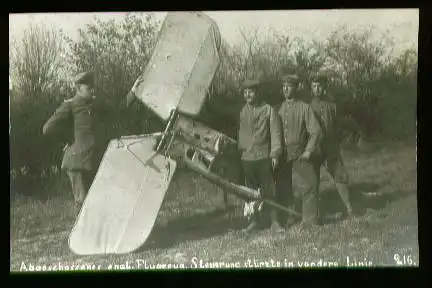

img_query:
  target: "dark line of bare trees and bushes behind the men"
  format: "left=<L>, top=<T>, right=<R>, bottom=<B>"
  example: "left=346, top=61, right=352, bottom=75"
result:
left=9, top=13, right=417, bottom=196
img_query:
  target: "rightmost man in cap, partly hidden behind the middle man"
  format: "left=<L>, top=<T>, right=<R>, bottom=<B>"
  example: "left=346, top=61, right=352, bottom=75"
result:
left=311, top=74, right=353, bottom=216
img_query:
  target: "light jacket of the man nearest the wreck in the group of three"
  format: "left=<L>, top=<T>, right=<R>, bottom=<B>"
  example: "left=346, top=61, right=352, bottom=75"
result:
left=238, top=104, right=282, bottom=161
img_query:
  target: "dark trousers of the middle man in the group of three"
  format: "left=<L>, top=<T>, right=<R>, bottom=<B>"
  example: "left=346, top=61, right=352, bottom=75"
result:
left=276, top=158, right=321, bottom=225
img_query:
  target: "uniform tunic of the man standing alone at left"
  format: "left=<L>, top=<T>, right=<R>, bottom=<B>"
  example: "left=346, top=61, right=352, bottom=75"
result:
left=43, top=96, right=95, bottom=171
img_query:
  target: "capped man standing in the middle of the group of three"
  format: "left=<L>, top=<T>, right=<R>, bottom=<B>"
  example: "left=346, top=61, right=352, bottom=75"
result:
left=276, top=75, right=322, bottom=226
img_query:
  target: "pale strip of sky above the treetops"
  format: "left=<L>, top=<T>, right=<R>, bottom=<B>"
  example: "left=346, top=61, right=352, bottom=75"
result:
left=9, top=9, right=419, bottom=54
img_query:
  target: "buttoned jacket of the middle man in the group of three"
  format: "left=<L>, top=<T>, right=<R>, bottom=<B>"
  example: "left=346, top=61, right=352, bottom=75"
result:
left=279, top=99, right=322, bottom=161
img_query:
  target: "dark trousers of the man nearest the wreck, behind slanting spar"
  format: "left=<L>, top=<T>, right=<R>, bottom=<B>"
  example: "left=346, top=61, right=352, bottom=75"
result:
left=242, top=158, right=275, bottom=222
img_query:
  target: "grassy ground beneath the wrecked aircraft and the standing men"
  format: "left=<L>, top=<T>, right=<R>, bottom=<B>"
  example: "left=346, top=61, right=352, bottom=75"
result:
left=10, top=144, right=419, bottom=271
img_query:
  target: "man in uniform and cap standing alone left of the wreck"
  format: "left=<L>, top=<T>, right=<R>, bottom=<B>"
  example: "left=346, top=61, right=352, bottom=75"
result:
left=43, top=72, right=95, bottom=209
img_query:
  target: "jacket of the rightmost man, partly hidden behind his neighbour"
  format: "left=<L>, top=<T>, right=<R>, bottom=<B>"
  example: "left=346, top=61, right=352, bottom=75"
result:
left=310, top=98, right=339, bottom=155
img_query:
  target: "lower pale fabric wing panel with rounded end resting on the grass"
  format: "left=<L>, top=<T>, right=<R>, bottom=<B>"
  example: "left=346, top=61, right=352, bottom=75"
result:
left=69, top=137, right=176, bottom=255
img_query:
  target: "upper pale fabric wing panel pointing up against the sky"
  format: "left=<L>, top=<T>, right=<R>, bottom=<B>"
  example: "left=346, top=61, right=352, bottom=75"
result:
left=135, top=12, right=221, bottom=120
